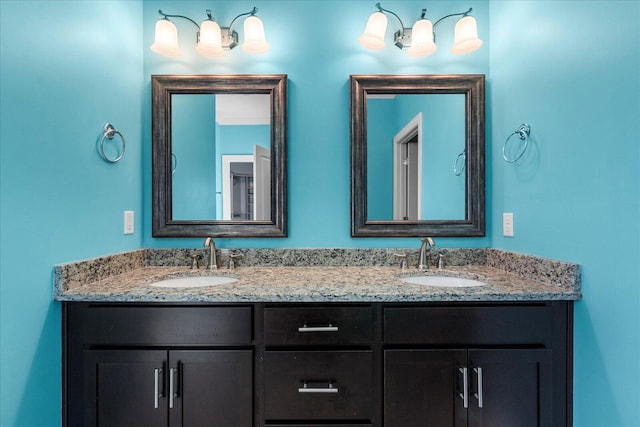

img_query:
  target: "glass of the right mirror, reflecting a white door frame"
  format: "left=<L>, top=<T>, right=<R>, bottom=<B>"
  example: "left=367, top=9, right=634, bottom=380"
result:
left=367, top=94, right=465, bottom=220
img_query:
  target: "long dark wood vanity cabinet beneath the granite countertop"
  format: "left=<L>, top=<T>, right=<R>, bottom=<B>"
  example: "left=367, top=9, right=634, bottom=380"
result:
left=63, top=301, right=573, bottom=427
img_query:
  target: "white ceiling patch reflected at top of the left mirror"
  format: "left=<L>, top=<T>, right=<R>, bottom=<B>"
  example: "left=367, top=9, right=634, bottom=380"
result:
left=216, top=94, right=271, bottom=125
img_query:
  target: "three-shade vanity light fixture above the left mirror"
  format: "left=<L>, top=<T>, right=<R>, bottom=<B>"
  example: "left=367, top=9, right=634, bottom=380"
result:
left=151, top=7, right=269, bottom=58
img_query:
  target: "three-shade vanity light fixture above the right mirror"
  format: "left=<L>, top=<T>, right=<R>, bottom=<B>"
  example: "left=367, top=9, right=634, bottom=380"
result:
left=358, top=3, right=482, bottom=57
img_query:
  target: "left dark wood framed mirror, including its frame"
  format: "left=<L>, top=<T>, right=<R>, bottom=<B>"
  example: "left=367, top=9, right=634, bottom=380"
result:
left=151, top=74, right=287, bottom=237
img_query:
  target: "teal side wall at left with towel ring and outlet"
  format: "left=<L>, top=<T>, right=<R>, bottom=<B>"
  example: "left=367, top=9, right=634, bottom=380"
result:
left=0, top=0, right=143, bottom=427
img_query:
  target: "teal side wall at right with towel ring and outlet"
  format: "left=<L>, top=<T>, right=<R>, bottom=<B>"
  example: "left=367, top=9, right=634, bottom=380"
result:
left=487, top=1, right=640, bottom=427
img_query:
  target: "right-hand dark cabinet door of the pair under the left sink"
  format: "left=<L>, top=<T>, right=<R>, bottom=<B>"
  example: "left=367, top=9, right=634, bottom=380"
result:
left=168, top=350, right=253, bottom=427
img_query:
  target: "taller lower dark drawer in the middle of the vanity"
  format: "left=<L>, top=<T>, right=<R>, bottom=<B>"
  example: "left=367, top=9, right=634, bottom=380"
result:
left=264, top=351, right=373, bottom=421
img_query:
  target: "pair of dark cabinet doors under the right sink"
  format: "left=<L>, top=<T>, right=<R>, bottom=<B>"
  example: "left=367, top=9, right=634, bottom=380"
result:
left=384, top=349, right=554, bottom=427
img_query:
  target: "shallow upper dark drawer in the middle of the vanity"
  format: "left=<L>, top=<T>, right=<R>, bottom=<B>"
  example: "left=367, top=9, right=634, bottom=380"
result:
left=264, top=307, right=373, bottom=346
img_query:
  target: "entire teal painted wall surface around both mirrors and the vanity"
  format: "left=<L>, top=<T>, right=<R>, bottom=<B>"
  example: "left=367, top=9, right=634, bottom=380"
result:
left=0, top=0, right=640, bottom=427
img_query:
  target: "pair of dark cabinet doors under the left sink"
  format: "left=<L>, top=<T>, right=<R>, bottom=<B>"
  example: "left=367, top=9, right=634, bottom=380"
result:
left=83, top=349, right=253, bottom=427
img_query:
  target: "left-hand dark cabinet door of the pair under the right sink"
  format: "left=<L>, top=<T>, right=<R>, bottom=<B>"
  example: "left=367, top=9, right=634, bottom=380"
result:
left=384, top=350, right=468, bottom=427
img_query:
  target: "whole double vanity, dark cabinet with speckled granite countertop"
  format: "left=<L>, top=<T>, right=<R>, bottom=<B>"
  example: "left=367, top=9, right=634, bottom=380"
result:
left=55, top=249, right=580, bottom=427
